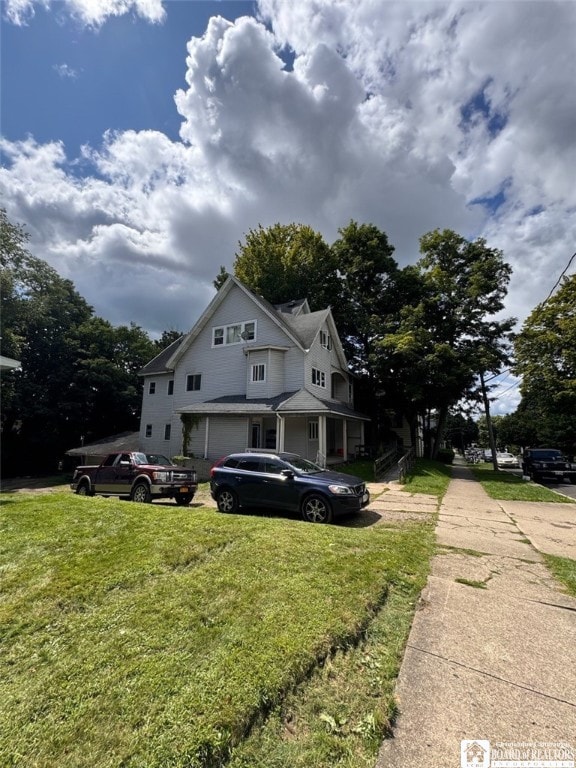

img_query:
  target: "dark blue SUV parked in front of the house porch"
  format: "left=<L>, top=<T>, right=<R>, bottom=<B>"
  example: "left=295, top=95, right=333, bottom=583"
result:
left=210, top=452, right=370, bottom=523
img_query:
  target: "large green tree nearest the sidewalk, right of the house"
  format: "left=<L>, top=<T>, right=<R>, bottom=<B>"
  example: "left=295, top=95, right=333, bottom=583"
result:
left=380, top=230, right=514, bottom=456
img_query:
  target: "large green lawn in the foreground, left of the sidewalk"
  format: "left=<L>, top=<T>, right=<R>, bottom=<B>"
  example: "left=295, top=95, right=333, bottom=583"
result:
left=0, top=492, right=433, bottom=768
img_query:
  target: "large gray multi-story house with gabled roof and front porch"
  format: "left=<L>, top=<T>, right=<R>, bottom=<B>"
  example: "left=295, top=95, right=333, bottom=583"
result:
left=140, top=277, right=369, bottom=465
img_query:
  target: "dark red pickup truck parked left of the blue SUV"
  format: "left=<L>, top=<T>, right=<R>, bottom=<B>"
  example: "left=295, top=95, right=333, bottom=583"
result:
left=70, top=452, right=198, bottom=506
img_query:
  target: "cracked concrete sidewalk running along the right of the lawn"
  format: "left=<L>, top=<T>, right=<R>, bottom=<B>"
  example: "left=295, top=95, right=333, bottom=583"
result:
left=376, top=466, right=576, bottom=768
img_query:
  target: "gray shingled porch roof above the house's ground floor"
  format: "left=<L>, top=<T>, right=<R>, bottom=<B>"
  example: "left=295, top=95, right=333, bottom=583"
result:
left=177, top=389, right=370, bottom=421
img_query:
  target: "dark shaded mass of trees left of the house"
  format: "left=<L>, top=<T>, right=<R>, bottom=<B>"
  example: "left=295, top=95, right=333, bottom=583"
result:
left=0, top=210, right=157, bottom=474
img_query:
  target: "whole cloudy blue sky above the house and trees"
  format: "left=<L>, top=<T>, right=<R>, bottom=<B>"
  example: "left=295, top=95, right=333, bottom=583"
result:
left=0, top=0, right=576, bottom=411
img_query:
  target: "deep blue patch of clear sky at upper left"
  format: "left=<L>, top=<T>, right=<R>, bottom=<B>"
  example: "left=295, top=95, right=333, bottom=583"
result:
left=1, top=0, right=255, bottom=155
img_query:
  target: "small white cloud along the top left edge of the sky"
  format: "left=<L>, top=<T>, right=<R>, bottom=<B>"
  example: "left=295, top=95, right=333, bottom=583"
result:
left=4, top=0, right=166, bottom=27
